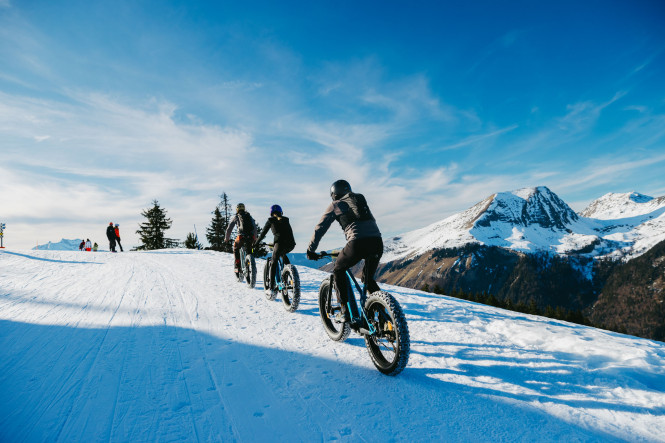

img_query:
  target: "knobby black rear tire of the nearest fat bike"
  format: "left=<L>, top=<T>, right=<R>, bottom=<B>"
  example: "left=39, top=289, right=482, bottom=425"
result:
left=365, top=291, right=411, bottom=376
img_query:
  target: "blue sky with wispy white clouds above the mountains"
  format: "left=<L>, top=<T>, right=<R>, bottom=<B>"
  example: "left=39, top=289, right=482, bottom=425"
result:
left=0, top=0, right=665, bottom=252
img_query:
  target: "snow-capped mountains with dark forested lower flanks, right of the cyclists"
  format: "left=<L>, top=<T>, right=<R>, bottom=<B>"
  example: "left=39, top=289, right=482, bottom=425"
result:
left=378, top=187, right=665, bottom=340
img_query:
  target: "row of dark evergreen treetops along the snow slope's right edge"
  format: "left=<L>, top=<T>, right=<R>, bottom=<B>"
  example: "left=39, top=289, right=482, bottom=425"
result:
left=421, top=283, right=592, bottom=326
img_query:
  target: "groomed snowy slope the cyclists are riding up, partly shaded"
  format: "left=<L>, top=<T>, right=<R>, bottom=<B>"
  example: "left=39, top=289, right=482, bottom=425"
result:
left=0, top=250, right=665, bottom=442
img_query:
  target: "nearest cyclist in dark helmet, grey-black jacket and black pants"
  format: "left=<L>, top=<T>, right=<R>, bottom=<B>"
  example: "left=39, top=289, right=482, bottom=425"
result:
left=307, top=180, right=383, bottom=327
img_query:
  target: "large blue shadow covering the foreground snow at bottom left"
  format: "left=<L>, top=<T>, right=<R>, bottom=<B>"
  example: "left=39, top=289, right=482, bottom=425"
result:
left=0, top=320, right=632, bottom=441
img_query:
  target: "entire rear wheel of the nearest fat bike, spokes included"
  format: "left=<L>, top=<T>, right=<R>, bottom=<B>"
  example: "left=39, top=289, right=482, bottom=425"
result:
left=365, top=291, right=411, bottom=375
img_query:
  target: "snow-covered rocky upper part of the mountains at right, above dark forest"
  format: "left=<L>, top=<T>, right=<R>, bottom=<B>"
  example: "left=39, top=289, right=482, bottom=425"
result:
left=382, top=186, right=665, bottom=262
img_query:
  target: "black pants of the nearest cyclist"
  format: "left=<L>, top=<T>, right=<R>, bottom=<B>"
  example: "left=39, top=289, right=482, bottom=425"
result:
left=333, top=237, right=383, bottom=312
